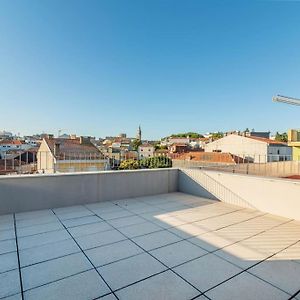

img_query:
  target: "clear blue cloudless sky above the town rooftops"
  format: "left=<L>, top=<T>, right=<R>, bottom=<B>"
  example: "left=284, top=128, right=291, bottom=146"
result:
left=0, top=0, right=300, bottom=139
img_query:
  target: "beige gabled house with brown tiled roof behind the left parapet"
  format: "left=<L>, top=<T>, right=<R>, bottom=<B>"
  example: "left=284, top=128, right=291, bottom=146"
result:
left=37, top=136, right=107, bottom=173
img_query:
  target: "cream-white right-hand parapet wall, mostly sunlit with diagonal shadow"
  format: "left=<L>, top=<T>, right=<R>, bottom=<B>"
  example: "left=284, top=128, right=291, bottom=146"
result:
left=179, top=169, right=300, bottom=220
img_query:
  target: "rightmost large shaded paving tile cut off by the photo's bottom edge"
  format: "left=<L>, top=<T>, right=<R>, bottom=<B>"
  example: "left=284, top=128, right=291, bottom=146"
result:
left=206, top=272, right=289, bottom=300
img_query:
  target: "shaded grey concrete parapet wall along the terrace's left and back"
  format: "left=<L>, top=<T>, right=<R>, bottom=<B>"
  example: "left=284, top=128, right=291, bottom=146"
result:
left=0, top=168, right=178, bottom=214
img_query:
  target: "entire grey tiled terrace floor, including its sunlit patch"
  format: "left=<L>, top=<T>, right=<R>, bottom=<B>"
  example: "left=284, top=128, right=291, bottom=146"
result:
left=0, top=193, right=300, bottom=300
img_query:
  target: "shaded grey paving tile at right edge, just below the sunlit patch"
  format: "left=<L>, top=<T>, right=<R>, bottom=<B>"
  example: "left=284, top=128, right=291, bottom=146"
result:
left=248, top=258, right=300, bottom=295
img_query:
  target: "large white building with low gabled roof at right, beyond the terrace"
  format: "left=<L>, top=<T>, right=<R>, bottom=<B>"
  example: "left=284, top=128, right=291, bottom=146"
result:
left=205, top=134, right=292, bottom=163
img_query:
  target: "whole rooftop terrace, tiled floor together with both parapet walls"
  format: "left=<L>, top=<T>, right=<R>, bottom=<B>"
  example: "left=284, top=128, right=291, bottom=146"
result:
left=0, top=169, right=300, bottom=300
